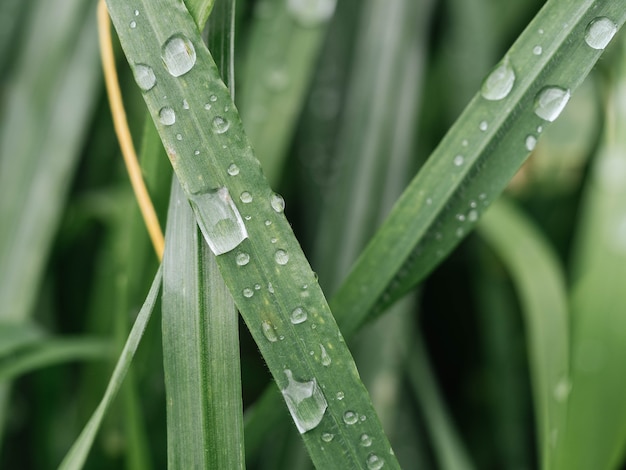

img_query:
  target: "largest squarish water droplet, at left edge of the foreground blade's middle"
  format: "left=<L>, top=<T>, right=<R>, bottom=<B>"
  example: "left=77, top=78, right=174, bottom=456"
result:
left=189, top=188, right=248, bottom=256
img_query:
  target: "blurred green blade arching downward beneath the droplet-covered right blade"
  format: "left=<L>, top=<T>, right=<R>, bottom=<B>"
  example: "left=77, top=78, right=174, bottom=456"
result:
left=478, top=200, right=570, bottom=468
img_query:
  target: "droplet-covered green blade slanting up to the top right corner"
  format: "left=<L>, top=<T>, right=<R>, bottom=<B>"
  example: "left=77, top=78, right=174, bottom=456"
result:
left=331, top=0, right=626, bottom=332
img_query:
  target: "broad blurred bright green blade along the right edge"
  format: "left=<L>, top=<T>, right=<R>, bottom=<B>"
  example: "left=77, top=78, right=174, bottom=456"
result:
left=558, top=35, right=626, bottom=469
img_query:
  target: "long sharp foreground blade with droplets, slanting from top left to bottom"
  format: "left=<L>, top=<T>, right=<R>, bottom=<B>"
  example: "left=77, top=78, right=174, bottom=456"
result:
left=102, top=0, right=397, bottom=468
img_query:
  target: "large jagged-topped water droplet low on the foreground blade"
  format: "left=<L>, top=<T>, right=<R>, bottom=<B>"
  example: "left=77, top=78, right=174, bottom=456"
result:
left=281, top=369, right=328, bottom=434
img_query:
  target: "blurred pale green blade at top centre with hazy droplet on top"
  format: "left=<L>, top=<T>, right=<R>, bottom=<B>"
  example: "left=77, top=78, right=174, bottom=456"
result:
left=237, top=0, right=336, bottom=185
